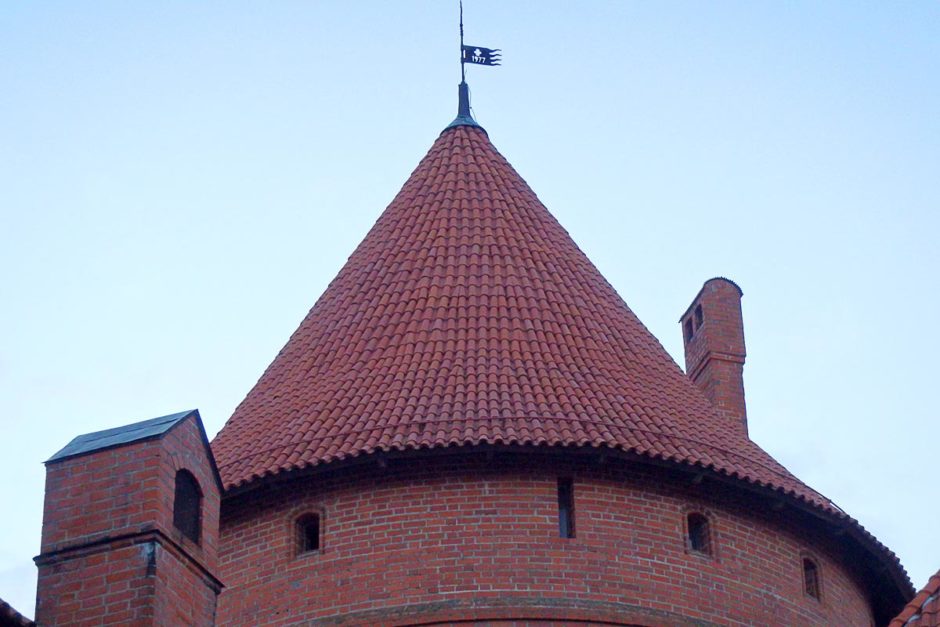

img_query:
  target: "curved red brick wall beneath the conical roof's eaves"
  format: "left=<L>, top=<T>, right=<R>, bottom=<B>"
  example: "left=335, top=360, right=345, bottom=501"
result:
left=219, top=454, right=871, bottom=625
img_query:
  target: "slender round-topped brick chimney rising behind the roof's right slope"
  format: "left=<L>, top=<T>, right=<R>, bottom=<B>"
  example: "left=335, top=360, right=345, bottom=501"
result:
left=679, top=277, right=747, bottom=435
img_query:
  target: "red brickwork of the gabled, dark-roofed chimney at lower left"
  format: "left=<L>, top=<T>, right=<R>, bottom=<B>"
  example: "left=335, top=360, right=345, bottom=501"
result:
left=36, top=418, right=220, bottom=625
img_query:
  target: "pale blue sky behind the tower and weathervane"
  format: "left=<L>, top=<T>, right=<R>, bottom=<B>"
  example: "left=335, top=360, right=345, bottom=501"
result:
left=0, top=0, right=940, bottom=615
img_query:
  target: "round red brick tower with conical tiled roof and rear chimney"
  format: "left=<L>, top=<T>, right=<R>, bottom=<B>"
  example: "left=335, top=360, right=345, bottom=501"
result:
left=204, top=91, right=913, bottom=625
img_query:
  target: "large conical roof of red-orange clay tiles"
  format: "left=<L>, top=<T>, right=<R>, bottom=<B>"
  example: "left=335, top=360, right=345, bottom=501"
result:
left=213, top=126, right=828, bottom=507
